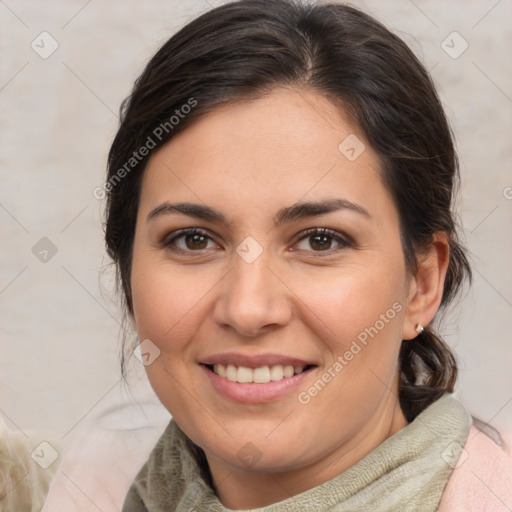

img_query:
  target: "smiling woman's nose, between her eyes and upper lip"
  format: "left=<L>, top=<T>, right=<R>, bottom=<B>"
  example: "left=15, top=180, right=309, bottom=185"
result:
left=214, top=251, right=292, bottom=338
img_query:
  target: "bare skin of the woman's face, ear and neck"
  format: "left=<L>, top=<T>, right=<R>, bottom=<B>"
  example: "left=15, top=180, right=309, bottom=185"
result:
left=132, top=89, right=448, bottom=509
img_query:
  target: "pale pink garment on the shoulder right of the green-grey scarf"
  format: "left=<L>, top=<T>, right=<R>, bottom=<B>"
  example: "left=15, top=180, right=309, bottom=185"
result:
left=438, top=425, right=512, bottom=512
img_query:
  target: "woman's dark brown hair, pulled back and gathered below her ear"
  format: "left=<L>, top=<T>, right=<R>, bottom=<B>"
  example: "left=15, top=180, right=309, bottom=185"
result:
left=105, top=0, right=471, bottom=421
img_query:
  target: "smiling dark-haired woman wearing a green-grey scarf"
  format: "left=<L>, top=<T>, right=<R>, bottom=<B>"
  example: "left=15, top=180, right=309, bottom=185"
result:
left=101, top=0, right=512, bottom=512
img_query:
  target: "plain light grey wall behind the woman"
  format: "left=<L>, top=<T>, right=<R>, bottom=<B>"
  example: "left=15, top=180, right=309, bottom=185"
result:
left=0, top=0, right=512, bottom=456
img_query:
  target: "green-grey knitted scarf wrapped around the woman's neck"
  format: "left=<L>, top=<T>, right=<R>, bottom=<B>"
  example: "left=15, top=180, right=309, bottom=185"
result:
left=123, top=394, right=484, bottom=512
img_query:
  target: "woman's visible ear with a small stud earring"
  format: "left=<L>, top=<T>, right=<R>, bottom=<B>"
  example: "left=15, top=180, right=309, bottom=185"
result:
left=402, top=232, right=450, bottom=340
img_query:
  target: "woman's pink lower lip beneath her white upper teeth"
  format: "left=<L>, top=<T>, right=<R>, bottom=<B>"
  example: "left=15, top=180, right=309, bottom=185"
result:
left=201, top=365, right=313, bottom=404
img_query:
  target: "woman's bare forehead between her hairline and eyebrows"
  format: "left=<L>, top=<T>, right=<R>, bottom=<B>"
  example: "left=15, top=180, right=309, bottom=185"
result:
left=141, top=89, right=392, bottom=227
